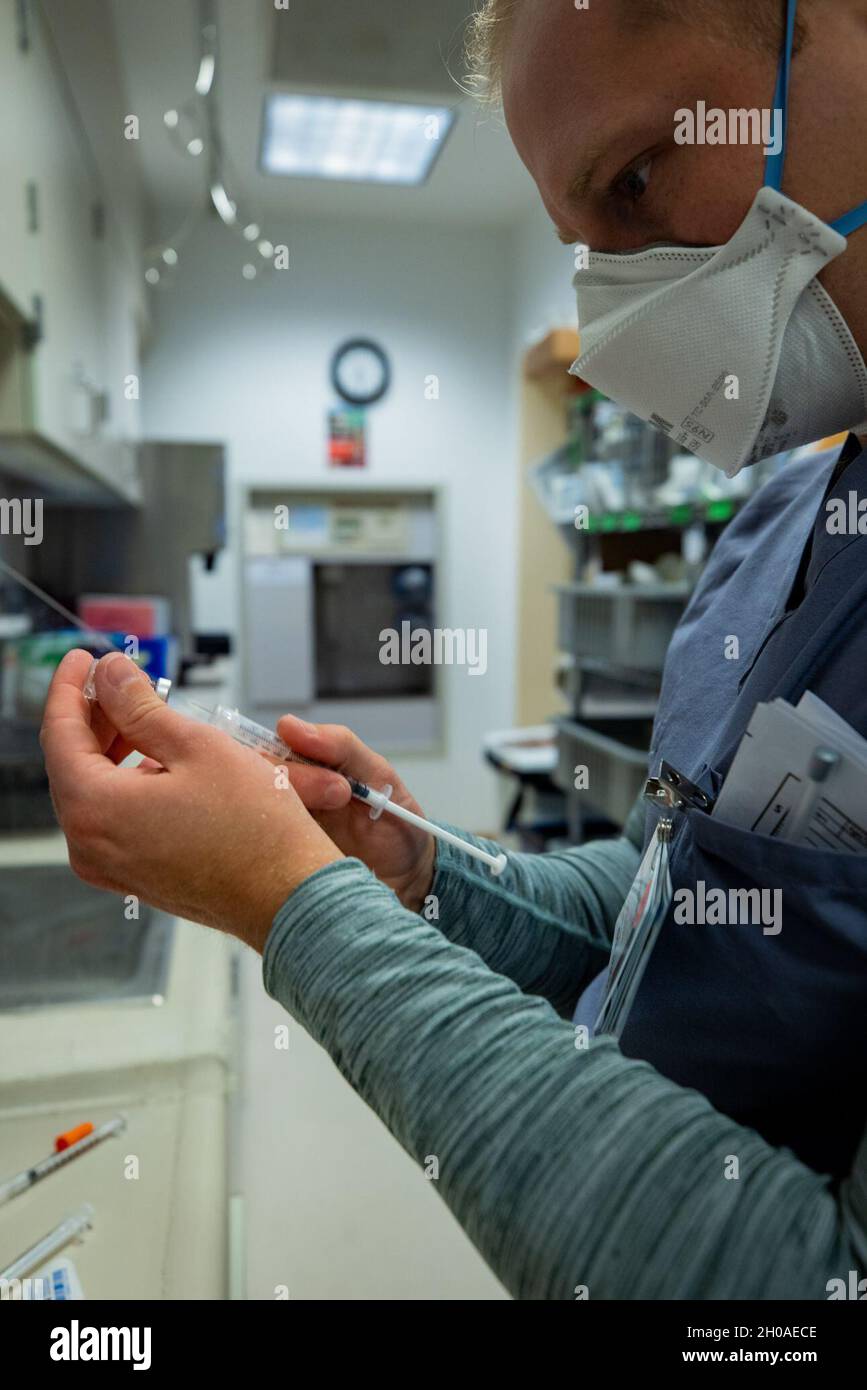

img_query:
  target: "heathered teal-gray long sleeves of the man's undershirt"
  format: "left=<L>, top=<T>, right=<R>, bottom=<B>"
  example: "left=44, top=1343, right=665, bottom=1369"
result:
left=264, top=809, right=867, bottom=1300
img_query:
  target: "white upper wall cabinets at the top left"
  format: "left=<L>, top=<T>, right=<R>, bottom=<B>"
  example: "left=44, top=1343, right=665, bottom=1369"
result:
left=0, top=0, right=138, bottom=500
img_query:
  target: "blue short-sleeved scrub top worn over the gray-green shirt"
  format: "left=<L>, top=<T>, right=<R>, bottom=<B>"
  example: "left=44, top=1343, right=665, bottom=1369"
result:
left=575, top=436, right=867, bottom=1176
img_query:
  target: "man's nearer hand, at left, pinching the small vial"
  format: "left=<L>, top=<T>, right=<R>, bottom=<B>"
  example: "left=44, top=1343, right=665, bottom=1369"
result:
left=42, top=651, right=343, bottom=951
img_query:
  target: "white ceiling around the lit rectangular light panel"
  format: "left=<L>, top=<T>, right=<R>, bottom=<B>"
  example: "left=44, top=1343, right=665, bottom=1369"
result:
left=108, top=0, right=535, bottom=231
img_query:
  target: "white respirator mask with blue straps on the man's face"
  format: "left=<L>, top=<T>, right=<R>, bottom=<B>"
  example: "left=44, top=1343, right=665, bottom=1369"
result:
left=570, top=0, right=867, bottom=477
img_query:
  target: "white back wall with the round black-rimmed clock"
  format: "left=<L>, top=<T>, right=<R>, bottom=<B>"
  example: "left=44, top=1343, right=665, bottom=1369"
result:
left=142, top=211, right=515, bottom=830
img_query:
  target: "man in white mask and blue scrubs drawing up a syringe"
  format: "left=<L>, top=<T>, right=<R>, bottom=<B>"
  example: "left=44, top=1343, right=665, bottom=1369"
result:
left=43, top=0, right=867, bottom=1300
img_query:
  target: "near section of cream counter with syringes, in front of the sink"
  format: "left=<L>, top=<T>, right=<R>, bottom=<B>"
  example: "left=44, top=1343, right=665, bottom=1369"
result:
left=0, top=1059, right=228, bottom=1300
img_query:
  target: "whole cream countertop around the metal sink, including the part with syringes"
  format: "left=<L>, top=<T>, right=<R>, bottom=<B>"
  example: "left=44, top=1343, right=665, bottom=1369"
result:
left=0, top=856, right=242, bottom=1300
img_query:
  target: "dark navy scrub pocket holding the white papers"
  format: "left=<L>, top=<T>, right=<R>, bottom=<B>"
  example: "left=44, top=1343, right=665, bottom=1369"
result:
left=621, top=800, right=867, bottom=1177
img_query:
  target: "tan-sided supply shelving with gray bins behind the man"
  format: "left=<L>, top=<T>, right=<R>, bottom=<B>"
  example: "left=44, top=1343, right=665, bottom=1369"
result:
left=517, top=329, right=742, bottom=841
